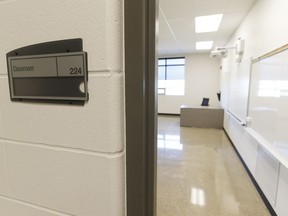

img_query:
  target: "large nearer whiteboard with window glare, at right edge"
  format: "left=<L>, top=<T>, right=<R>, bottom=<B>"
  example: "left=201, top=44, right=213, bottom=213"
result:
left=248, top=51, right=288, bottom=150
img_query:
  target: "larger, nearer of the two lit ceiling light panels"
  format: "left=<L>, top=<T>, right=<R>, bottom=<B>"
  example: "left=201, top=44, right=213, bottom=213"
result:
left=195, top=14, right=223, bottom=33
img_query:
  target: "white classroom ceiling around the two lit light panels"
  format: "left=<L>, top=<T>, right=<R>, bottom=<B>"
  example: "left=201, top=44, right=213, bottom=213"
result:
left=158, top=0, right=257, bottom=56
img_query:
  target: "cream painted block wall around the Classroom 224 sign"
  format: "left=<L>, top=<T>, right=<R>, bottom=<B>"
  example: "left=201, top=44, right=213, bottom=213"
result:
left=0, top=0, right=125, bottom=216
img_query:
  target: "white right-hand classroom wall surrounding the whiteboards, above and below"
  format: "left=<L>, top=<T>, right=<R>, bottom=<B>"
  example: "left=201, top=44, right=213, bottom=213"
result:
left=221, top=0, right=288, bottom=216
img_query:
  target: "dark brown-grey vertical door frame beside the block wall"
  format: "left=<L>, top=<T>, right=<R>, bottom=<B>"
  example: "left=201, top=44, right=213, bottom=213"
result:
left=124, top=0, right=158, bottom=216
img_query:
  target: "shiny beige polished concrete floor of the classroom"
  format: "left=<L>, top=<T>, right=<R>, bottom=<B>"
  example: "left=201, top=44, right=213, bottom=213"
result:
left=157, top=116, right=270, bottom=216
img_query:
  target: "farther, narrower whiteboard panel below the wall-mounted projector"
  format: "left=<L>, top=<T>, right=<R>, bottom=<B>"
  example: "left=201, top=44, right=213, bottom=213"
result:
left=228, top=58, right=252, bottom=124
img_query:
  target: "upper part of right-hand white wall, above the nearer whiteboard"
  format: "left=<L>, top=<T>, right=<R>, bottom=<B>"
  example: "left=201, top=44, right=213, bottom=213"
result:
left=224, top=0, right=288, bottom=62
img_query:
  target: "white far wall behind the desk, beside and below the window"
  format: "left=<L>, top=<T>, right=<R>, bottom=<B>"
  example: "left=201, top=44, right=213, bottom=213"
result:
left=158, top=54, right=220, bottom=114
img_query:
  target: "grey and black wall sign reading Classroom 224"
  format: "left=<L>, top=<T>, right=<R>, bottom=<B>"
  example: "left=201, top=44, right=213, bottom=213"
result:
left=7, top=39, right=88, bottom=104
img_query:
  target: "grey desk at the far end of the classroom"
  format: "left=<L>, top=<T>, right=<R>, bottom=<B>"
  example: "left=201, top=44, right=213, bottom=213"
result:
left=180, top=105, right=224, bottom=128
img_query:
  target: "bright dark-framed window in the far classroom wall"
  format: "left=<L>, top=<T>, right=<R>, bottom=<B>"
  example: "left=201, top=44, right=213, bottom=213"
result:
left=158, top=57, right=185, bottom=95
